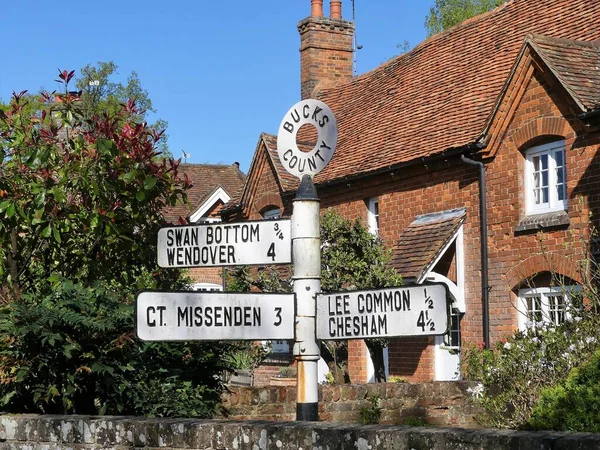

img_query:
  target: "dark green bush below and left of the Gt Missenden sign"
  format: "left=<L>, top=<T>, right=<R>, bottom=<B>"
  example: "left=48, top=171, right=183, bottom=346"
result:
left=0, top=281, right=228, bottom=417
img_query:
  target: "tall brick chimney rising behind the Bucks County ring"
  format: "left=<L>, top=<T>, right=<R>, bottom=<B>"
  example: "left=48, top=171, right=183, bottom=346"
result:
left=298, top=0, right=354, bottom=99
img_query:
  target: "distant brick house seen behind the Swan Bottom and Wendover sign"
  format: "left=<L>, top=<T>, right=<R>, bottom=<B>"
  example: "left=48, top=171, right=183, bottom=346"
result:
left=164, top=162, right=246, bottom=291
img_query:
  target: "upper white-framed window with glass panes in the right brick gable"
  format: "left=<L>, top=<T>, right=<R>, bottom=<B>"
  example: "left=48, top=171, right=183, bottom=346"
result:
left=525, top=141, right=567, bottom=214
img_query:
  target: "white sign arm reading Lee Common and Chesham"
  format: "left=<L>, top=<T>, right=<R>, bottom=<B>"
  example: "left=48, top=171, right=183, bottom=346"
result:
left=317, top=284, right=448, bottom=340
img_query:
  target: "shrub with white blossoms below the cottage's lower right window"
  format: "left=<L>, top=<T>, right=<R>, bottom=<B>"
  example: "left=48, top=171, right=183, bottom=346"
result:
left=463, top=309, right=600, bottom=428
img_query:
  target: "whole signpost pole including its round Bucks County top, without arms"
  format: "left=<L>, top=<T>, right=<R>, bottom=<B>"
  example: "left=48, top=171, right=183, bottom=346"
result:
left=277, top=99, right=337, bottom=421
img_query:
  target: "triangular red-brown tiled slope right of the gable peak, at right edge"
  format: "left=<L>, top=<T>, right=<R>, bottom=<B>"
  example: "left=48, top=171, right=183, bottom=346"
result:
left=527, top=35, right=600, bottom=112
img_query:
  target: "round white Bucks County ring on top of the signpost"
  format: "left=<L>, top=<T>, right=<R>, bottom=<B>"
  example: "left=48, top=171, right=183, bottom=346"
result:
left=277, top=99, right=337, bottom=179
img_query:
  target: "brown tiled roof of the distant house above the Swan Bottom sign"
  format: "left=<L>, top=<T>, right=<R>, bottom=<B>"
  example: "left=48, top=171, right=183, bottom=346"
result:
left=163, top=163, right=246, bottom=223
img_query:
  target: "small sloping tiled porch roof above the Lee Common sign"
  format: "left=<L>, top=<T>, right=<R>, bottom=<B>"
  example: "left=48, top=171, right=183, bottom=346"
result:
left=391, top=208, right=466, bottom=280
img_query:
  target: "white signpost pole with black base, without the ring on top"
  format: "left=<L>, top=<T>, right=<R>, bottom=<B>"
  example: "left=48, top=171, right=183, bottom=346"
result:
left=292, top=175, right=321, bottom=421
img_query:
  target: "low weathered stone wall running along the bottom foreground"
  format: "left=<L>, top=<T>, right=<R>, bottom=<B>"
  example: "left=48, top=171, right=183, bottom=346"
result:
left=0, top=415, right=600, bottom=450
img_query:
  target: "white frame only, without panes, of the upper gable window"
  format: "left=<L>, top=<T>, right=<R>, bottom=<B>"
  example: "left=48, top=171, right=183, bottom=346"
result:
left=525, top=140, right=567, bottom=215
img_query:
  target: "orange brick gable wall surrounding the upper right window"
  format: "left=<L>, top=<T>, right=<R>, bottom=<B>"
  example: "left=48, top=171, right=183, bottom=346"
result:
left=487, top=74, right=599, bottom=341
